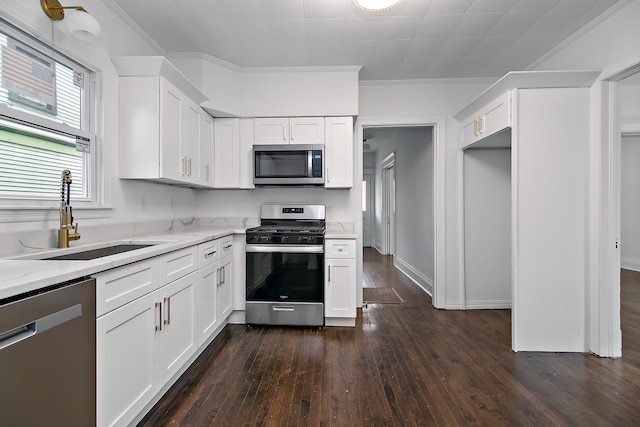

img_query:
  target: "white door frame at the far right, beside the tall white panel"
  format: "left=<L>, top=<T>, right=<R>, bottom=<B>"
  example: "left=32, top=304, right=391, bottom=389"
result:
left=586, top=54, right=640, bottom=357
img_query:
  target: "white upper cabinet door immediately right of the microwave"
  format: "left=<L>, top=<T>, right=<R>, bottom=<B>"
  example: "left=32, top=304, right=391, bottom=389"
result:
left=324, top=117, right=353, bottom=188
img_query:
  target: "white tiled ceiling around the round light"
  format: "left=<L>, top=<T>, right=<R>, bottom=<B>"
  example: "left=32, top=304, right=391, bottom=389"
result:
left=106, top=0, right=618, bottom=80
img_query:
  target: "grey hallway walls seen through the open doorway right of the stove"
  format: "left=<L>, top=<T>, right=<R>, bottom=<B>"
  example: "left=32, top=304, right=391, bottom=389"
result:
left=363, top=125, right=436, bottom=304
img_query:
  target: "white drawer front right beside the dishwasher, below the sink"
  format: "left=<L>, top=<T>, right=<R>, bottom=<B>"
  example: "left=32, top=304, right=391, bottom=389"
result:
left=95, top=259, right=160, bottom=317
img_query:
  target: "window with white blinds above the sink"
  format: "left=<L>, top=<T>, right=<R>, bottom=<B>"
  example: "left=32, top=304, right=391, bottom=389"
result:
left=0, top=21, right=95, bottom=200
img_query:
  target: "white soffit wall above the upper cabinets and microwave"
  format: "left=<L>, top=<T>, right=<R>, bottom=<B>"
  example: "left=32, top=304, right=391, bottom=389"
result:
left=170, top=54, right=360, bottom=117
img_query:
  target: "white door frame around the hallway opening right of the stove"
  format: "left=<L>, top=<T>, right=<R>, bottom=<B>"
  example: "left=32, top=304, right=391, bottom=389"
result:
left=352, top=115, right=447, bottom=308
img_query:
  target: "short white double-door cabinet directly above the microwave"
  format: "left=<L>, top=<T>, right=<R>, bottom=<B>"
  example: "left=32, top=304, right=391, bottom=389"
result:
left=254, top=117, right=325, bottom=144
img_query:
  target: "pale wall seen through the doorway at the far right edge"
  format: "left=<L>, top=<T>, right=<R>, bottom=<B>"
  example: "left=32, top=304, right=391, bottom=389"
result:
left=620, top=136, right=640, bottom=271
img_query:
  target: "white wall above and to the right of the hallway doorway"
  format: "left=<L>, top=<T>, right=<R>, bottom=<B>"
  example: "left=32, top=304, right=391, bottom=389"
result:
left=359, top=79, right=493, bottom=309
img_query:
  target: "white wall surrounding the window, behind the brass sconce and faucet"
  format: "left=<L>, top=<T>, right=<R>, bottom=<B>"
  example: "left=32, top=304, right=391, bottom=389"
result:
left=0, top=0, right=197, bottom=242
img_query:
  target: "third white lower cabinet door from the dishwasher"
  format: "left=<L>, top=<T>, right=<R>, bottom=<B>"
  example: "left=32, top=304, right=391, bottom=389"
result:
left=198, top=262, right=220, bottom=346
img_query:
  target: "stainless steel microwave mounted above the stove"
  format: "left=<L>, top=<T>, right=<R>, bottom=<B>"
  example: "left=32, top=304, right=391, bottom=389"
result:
left=253, top=144, right=324, bottom=186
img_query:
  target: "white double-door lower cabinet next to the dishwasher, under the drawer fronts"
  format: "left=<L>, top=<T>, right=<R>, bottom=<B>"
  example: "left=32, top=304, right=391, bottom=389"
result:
left=97, top=274, right=198, bottom=426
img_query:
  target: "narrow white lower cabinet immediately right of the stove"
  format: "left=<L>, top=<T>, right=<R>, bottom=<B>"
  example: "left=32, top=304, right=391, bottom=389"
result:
left=324, top=238, right=356, bottom=326
